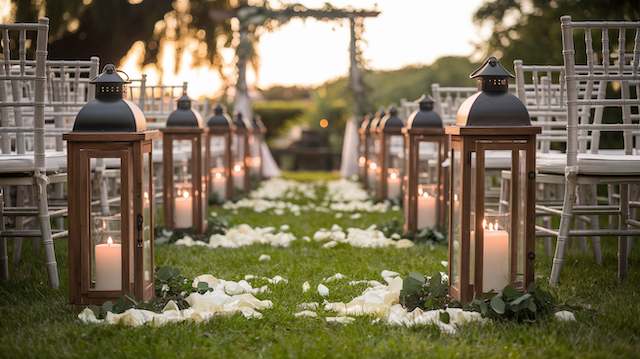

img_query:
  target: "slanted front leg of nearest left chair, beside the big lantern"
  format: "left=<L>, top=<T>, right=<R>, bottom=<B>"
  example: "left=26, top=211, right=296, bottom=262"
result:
left=35, top=172, right=60, bottom=289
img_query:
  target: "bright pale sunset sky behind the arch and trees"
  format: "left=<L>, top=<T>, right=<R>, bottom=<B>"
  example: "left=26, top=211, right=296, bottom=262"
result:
left=120, top=0, right=487, bottom=97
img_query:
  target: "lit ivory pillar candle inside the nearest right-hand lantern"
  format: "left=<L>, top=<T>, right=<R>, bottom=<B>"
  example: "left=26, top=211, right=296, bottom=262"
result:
left=471, top=219, right=510, bottom=293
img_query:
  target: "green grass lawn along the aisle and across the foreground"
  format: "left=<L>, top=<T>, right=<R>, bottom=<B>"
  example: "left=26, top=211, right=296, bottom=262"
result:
left=0, top=174, right=640, bottom=358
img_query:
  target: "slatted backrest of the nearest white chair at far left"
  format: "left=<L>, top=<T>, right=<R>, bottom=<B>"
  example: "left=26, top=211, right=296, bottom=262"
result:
left=0, top=18, right=49, bottom=170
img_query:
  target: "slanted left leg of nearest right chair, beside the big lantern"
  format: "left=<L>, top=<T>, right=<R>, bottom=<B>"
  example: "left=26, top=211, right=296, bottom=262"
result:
left=549, top=172, right=577, bottom=286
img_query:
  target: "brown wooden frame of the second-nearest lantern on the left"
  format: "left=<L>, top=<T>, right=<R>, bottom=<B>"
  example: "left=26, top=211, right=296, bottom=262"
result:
left=160, top=127, right=209, bottom=234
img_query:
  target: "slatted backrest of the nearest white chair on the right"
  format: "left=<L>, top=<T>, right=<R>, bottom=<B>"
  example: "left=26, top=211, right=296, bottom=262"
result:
left=561, top=16, right=640, bottom=166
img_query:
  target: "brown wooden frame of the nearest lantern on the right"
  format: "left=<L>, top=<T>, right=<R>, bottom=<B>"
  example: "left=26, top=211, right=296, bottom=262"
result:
left=445, top=126, right=540, bottom=302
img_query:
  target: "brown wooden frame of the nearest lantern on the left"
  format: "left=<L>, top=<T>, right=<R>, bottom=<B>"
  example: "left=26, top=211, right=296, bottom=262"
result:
left=63, top=131, right=160, bottom=305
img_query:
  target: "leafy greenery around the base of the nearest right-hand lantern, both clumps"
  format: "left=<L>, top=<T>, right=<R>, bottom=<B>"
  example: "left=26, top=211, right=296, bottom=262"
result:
left=400, top=273, right=561, bottom=322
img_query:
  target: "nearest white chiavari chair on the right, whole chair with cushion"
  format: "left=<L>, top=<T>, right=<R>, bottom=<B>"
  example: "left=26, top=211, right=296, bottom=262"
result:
left=547, top=16, right=640, bottom=285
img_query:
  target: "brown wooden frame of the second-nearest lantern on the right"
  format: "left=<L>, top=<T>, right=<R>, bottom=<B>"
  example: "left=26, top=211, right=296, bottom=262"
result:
left=402, top=127, right=449, bottom=234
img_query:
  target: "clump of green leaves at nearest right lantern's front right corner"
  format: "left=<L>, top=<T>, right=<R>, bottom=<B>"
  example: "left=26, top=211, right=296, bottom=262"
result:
left=468, top=284, right=557, bottom=322
